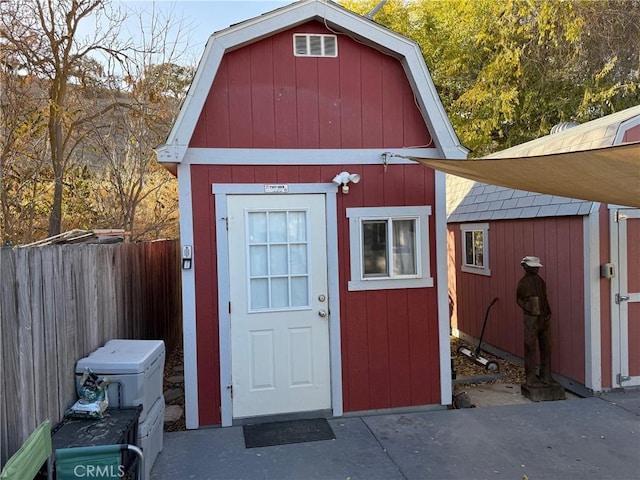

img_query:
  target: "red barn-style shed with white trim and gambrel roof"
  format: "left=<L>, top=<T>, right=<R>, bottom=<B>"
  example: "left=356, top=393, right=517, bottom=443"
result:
left=158, top=0, right=467, bottom=428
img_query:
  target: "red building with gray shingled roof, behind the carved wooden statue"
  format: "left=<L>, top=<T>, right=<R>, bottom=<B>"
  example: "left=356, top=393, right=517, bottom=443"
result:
left=447, top=106, right=640, bottom=395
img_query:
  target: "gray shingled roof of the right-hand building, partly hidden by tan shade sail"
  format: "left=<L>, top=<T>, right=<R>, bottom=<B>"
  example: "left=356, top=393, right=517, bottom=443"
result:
left=447, top=105, right=640, bottom=223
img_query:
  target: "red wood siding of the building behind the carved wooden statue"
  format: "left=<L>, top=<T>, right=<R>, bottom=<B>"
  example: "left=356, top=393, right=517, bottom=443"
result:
left=449, top=217, right=585, bottom=384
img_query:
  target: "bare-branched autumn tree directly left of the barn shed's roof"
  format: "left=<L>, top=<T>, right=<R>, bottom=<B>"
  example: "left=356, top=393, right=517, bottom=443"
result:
left=87, top=5, right=195, bottom=240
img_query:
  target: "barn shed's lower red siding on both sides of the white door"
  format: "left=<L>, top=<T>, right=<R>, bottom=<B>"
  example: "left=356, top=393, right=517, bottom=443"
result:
left=191, top=165, right=440, bottom=425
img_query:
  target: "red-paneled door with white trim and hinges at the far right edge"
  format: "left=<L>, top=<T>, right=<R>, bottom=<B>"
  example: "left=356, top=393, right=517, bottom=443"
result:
left=613, top=209, right=640, bottom=387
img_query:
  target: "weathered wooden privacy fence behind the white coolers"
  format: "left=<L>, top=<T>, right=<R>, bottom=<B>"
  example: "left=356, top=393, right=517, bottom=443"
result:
left=0, top=240, right=182, bottom=465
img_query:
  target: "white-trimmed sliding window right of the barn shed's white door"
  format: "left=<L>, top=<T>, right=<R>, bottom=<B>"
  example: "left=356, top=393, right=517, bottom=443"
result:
left=347, top=206, right=433, bottom=290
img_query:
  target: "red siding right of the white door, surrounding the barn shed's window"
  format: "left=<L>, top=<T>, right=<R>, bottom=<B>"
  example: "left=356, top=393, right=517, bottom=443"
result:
left=338, top=165, right=440, bottom=412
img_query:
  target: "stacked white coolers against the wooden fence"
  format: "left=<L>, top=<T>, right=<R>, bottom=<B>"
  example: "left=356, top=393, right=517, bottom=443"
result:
left=76, top=340, right=165, bottom=480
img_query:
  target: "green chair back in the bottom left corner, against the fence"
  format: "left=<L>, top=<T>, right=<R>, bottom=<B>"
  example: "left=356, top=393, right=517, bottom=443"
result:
left=0, top=420, right=51, bottom=480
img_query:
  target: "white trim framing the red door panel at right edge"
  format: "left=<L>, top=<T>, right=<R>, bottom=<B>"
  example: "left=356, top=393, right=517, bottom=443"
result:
left=609, top=205, right=640, bottom=388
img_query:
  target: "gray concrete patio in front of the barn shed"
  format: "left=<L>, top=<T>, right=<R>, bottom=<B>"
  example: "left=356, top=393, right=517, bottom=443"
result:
left=151, top=390, right=640, bottom=480
